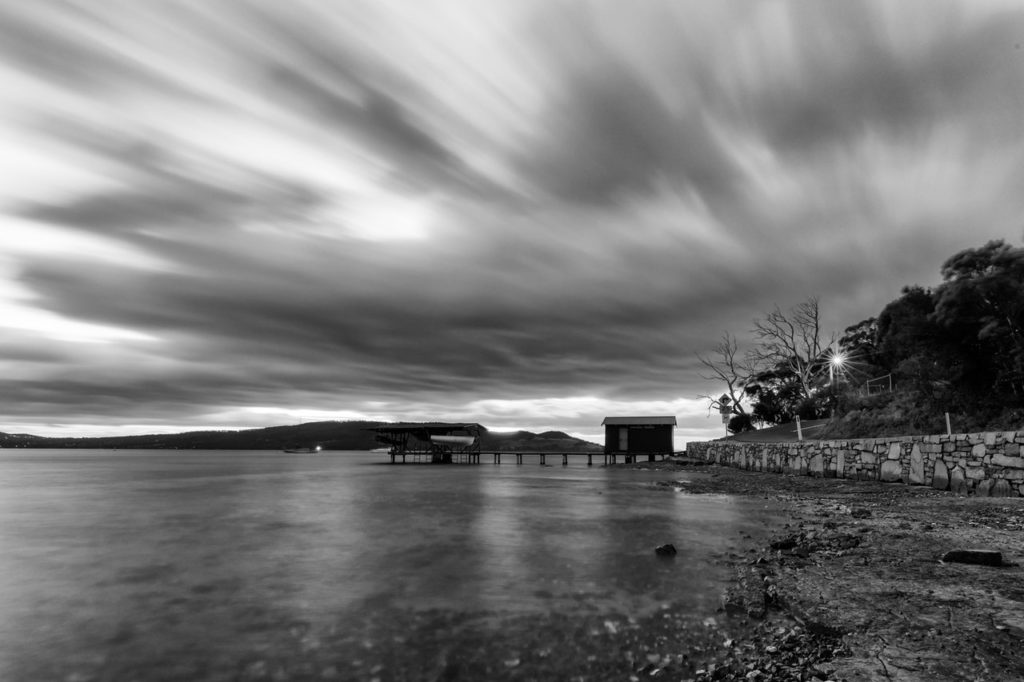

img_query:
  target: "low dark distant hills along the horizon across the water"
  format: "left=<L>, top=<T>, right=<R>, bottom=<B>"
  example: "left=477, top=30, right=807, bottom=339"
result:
left=0, top=422, right=601, bottom=452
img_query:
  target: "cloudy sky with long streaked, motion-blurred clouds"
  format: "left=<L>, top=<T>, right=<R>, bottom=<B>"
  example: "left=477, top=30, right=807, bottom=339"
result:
left=0, top=0, right=1024, bottom=442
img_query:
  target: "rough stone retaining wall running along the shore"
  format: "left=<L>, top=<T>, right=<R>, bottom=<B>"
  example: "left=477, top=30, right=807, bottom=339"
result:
left=686, top=431, right=1024, bottom=497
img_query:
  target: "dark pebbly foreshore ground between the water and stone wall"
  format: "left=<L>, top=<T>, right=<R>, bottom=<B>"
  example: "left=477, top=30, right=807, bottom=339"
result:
left=634, top=462, right=1024, bottom=681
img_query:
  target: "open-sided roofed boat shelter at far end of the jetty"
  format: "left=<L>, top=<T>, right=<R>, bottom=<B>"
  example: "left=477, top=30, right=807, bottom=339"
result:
left=370, top=422, right=482, bottom=464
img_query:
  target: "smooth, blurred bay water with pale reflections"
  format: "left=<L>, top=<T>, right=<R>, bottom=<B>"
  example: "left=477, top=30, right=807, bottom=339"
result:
left=0, top=450, right=764, bottom=682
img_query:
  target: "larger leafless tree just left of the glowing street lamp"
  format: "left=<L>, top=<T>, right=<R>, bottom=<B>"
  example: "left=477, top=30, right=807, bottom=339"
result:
left=748, top=296, right=835, bottom=397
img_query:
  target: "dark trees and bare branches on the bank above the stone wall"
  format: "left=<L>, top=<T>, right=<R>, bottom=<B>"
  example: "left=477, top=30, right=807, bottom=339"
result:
left=697, top=240, right=1024, bottom=436
